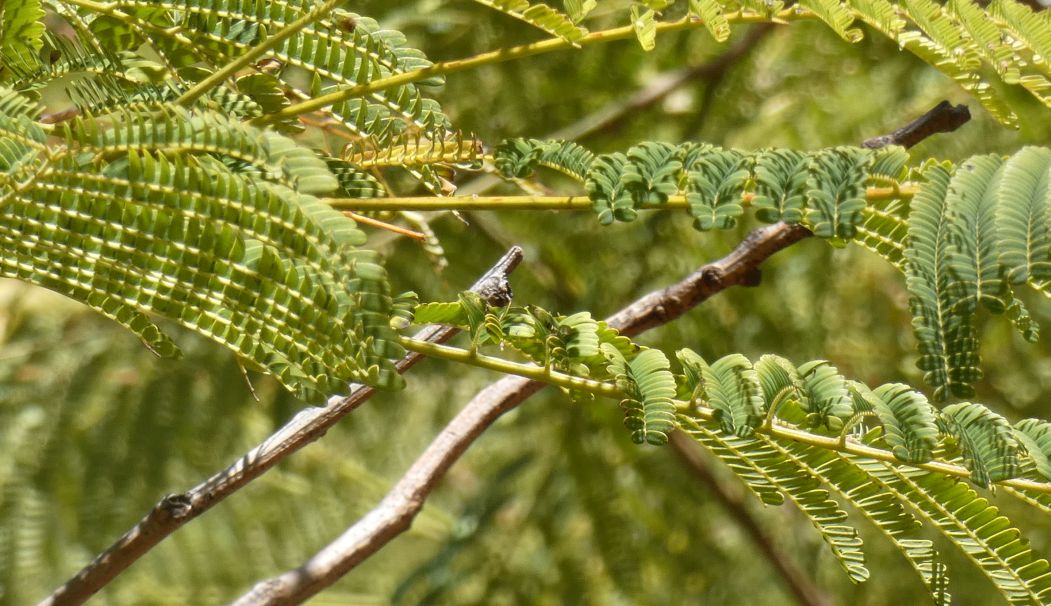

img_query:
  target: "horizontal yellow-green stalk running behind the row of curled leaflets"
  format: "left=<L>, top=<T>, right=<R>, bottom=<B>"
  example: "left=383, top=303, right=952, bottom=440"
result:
left=322, top=184, right=916, bottom=211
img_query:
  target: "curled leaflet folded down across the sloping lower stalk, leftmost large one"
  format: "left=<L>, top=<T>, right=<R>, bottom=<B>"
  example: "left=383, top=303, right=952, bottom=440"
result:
left=602, top=343, right=676, bottom=445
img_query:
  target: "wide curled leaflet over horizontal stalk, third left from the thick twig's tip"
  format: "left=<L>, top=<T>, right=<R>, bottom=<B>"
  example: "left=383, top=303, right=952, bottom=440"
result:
left=686, top=149, right=749, bottom=231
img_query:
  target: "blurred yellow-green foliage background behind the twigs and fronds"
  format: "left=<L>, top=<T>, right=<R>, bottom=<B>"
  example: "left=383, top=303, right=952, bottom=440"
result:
left=0, top=0, right=1051, bottom=605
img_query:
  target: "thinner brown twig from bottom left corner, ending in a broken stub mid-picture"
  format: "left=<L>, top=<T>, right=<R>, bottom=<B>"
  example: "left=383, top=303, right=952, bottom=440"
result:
left=40, top=246, right=522, bottom=606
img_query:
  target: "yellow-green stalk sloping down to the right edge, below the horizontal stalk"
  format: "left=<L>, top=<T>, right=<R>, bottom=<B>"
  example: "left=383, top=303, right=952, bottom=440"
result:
left=399, top=336, right=1051, bottom=495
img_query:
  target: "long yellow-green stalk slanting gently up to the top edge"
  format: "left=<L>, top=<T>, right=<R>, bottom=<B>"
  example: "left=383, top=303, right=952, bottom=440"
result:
left=252, top=7, right=815, bottom=125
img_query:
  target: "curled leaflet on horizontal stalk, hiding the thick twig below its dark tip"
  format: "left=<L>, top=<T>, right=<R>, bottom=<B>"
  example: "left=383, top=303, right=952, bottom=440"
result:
left=806, top=147, right=871, bottom=246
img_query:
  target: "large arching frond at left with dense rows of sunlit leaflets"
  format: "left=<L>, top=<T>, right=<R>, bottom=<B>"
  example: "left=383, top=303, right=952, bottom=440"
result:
left=0, top=91, right=401, bottom=399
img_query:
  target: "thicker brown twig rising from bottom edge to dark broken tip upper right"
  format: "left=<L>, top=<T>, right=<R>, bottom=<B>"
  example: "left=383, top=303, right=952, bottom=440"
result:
left=228, top=104, right=966, bottom=606
